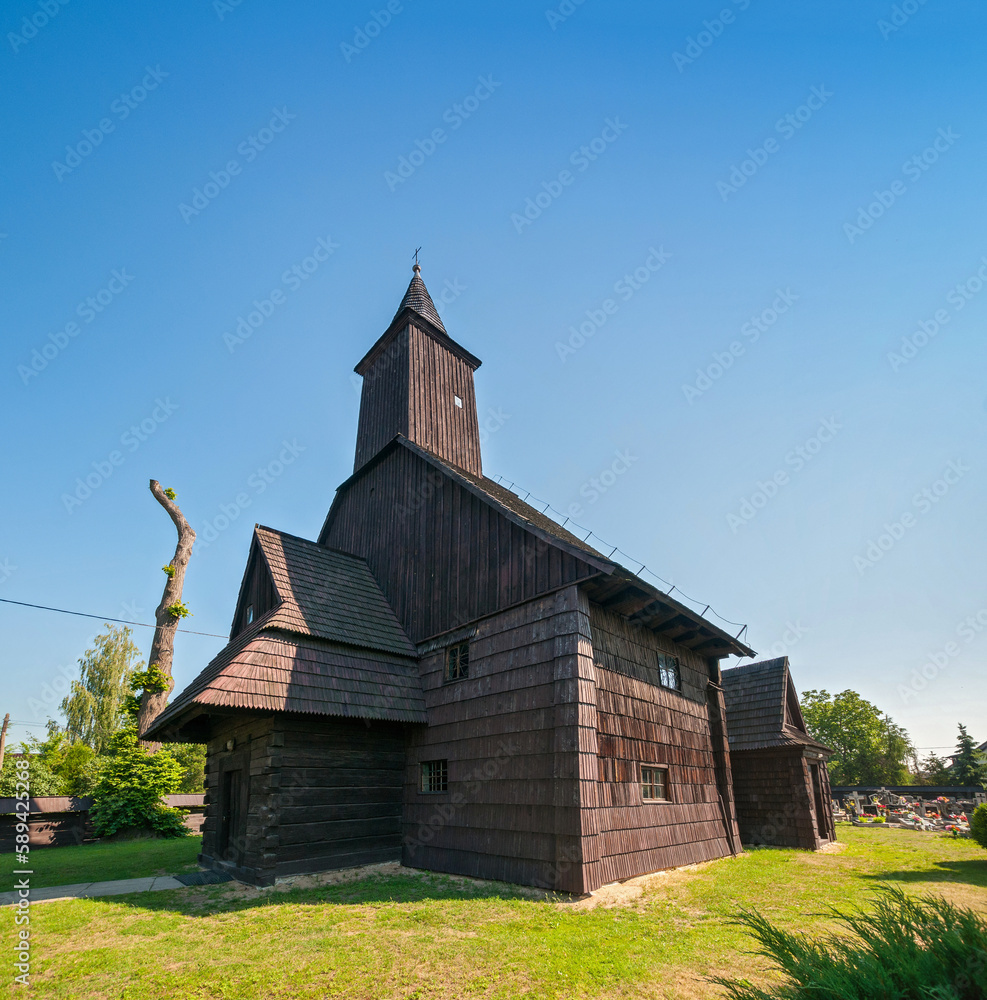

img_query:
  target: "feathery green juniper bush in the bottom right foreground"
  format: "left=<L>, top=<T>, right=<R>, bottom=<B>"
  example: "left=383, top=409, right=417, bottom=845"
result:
left=715, top=886, right=987, bottom=1000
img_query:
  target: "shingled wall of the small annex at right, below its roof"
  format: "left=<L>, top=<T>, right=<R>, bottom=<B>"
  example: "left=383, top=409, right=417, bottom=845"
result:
left=730, top=747, right=829, bottom=850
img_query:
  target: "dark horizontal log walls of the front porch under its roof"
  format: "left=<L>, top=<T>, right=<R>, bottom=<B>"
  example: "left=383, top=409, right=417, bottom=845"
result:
left=201, top=714, right=406, bottom=885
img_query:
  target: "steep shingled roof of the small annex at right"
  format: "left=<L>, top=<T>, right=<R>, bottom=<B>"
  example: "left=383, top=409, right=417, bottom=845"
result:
left=722, top=656, right=832, bottom=753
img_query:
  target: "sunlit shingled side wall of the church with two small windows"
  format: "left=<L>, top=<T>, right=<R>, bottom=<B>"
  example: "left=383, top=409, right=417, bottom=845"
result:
left=590, top=605, right=733, bottom=882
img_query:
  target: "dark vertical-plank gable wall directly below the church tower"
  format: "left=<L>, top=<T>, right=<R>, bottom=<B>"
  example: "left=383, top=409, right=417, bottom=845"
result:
left=320, top=447, right=594, bottom=642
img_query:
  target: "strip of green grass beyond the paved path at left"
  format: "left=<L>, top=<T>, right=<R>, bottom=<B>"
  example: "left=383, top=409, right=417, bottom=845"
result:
left=0, top=837, right=202, bottom=891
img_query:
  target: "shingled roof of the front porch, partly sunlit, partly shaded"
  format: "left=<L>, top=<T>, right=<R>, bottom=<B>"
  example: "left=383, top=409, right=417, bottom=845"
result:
left=146, top=525, right=426, bottom=739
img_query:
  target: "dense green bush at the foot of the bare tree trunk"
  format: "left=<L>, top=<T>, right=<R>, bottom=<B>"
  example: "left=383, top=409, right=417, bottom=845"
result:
left=90, top=725, right=190, bottom=837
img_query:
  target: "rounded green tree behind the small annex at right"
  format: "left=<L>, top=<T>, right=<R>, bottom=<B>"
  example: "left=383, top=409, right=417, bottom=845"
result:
left=802, top=690, right=915, bottom=785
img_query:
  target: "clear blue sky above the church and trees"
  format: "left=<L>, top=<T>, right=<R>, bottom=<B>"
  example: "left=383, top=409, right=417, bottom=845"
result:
left=0, top=0, right=987, bottom=747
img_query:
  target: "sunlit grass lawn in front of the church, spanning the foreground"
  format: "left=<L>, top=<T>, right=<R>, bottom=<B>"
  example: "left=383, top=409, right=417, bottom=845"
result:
left=0, top=826, right=987, bottom=1000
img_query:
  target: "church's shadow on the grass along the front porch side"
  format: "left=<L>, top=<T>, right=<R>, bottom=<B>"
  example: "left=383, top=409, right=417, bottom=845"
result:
left=92, top=874, right=548, bottom=917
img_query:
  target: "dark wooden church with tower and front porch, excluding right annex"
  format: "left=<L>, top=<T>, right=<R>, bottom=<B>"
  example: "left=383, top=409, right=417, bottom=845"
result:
left=147, top=264, right=824, bottom=893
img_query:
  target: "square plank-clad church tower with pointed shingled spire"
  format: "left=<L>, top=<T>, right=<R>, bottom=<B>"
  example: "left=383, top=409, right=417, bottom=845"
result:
left=354, top=263, right=483, bottom=476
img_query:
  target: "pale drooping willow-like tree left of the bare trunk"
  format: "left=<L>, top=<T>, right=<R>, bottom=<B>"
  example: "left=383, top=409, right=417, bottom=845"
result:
left=61, top=625, right=144, bottom=754
